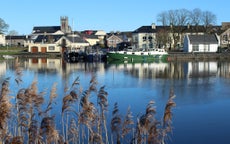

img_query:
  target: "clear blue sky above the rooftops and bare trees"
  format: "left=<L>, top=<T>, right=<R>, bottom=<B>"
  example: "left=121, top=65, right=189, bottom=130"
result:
left=0, top=0, right=230, bottom=34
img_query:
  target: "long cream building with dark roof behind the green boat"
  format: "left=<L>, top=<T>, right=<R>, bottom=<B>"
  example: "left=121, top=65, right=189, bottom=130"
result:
left=132, top=23, right=221, bottom=49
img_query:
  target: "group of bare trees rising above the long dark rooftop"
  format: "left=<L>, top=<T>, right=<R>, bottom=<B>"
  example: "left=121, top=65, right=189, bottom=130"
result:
left=156, top=8, right=217, bottom=49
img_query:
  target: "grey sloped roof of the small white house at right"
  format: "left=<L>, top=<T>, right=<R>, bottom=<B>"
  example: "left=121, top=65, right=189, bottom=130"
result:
left=188, top=34, right=218, bottom=44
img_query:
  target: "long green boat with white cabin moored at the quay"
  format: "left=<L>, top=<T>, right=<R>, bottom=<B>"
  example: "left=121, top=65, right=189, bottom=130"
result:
left=107, top=49, right=168, bottom=62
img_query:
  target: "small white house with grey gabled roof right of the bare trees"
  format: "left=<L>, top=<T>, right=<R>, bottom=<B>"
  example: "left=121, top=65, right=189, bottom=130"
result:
left=184, top=34, right=219, bottom=52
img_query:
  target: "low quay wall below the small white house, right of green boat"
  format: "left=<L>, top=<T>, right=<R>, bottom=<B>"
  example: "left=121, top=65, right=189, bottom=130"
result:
left=168, top=52, right=230, bottom=61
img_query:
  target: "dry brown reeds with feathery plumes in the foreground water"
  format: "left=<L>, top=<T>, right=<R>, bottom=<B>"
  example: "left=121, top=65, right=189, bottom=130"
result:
left=0, top=65, right=176, bottom=144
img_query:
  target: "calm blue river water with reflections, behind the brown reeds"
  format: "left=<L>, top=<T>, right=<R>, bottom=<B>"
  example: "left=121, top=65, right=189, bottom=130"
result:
left=0, top=59, right=230, bottom=144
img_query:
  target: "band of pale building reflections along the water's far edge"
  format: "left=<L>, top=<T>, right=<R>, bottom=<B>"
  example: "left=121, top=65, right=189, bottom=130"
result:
left=4, top=58, right=230, bottom=79
